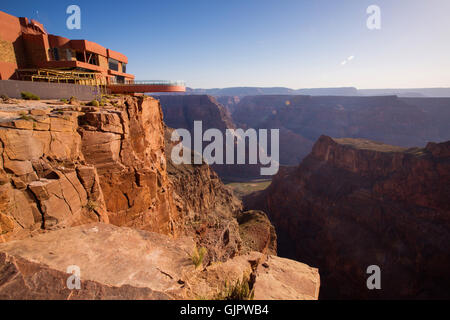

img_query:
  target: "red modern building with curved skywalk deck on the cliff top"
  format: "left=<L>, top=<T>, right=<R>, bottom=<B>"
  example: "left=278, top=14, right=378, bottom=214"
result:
left=0, top=11, right=185, bottom=93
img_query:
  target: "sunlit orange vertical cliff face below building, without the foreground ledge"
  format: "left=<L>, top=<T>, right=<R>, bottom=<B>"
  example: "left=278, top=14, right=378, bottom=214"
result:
left=0, top=97, right=179, bottom=241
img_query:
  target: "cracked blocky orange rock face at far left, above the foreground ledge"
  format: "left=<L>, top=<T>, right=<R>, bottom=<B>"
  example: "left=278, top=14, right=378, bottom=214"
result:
left=0, top=108, right=107, bottom=241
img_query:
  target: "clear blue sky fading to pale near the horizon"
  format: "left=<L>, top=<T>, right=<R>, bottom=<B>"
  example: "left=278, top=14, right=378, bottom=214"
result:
left=0, top=0, right=450, bottom=89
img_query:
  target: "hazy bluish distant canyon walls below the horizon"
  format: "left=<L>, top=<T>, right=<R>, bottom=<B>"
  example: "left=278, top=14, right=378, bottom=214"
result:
left=157, top=94, right=450, bottom=180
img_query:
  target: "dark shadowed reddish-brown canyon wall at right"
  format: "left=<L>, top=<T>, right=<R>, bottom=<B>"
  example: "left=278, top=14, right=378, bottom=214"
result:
left=244, top=136, right=450, bottom=299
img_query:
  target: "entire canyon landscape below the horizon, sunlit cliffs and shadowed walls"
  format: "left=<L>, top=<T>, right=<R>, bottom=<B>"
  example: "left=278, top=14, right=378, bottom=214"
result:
left=0, top=95, right=450, bottom=299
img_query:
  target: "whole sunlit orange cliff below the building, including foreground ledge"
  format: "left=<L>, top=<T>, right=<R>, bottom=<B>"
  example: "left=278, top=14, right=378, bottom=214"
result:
left=0, top=96, right=320, bottom=299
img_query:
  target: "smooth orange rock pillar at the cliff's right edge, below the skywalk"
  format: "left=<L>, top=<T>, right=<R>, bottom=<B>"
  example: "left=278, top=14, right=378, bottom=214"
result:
left=78, top=97, right=177, bottom=234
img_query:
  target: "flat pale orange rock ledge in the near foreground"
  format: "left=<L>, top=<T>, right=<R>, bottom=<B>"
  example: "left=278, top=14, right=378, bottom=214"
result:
left=0, top=223, right=320, bottom=300
